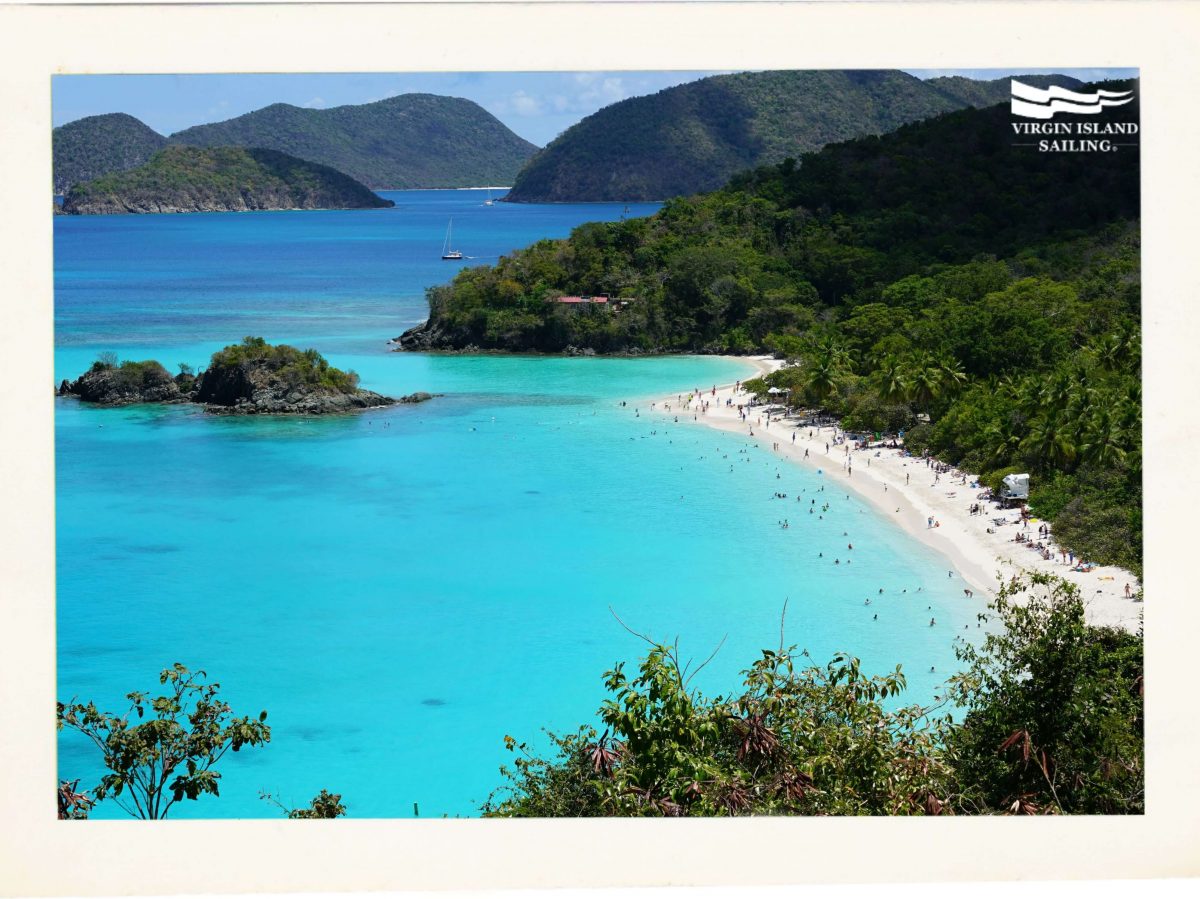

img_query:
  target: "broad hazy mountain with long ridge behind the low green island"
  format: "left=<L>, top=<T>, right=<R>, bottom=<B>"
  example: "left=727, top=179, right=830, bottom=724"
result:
left=170, top=94, right=538, bottom=190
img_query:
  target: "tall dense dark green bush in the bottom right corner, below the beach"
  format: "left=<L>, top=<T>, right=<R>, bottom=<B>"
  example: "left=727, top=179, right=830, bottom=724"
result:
left=947, top=575, right=1145, bottom=815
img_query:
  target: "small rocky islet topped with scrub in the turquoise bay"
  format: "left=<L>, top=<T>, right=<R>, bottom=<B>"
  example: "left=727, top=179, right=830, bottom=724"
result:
left=58, top=337, right=433, bottom=415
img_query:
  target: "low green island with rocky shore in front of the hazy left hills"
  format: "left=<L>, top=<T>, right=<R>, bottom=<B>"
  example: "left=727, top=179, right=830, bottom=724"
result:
left=62, top=146, right=395, bottom=215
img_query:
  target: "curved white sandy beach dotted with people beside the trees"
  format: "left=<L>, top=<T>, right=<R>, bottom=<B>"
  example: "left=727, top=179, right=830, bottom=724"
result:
left=652, top=356, right=1142, bottom=631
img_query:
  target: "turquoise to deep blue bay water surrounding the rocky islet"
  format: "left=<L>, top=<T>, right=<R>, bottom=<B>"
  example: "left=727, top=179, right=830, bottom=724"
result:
left=55, top=192, right=977, bottom=817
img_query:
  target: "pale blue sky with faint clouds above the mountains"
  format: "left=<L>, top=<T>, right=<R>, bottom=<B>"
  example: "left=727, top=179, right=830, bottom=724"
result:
left=53, top=68, right=1136, bottom=146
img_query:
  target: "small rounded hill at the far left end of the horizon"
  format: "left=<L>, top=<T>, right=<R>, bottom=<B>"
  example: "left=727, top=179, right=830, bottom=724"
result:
left=53, top=113, right=167, bottom=193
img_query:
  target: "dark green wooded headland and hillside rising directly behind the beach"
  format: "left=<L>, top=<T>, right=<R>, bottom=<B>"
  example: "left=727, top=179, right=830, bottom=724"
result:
left=400, top=91, right=1141, bottom=568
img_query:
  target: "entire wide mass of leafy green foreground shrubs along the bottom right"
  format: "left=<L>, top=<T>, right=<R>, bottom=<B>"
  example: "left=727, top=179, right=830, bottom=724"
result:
left=484, top=577, right=1144, bottom=817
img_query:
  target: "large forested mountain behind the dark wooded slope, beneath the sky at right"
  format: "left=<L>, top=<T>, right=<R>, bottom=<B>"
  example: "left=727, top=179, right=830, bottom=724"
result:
left=505, top=71, right=1084, bottom=203
